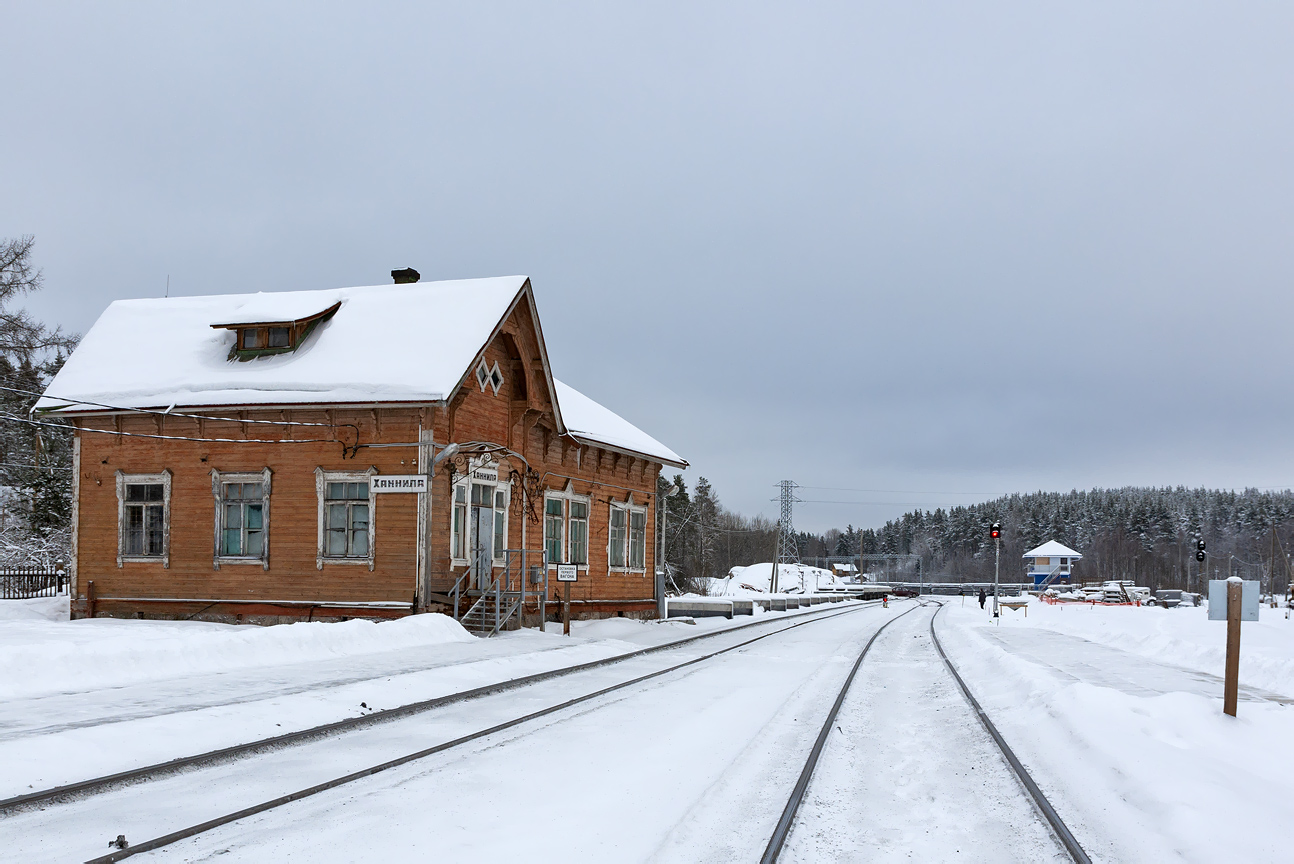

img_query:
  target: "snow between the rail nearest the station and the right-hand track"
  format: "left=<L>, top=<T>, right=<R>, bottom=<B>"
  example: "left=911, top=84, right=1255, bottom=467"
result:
left=0, top=604, right=893, bottom=861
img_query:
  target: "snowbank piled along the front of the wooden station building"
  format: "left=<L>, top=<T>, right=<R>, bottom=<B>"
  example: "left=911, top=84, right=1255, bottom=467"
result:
left=0, top=607, right=476, bottom=698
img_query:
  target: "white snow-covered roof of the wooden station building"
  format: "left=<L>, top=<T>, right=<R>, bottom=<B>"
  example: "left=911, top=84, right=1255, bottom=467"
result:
left=36, top=275, right=687, bottom=467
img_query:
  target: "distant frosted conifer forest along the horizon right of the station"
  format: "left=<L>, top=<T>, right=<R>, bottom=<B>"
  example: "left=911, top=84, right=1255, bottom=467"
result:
left=660, top=476, right=1294, bottom=591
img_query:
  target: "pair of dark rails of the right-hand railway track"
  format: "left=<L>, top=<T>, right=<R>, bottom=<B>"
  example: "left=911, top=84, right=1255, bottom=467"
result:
left=760, top=600, right=1091, bottom=864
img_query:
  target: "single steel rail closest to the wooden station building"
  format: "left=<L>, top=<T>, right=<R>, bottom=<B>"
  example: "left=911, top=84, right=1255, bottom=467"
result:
left=0, top=600, right=876, bottom=815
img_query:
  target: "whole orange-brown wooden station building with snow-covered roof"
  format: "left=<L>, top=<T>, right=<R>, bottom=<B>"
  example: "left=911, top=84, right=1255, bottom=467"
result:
left=36, top=270, right=687, bottom=626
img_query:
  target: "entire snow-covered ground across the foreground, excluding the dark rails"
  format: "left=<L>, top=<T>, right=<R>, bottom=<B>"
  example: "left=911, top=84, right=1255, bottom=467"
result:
left=0, top=589, right=1294, bottom=864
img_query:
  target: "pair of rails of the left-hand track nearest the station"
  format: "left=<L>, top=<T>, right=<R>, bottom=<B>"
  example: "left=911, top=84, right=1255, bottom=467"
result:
left=0, top=604, right=895, bottom=864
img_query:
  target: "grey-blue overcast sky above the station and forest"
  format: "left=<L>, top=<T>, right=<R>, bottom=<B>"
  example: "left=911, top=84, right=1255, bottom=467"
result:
left=0, top=0, right=1294, bottom=529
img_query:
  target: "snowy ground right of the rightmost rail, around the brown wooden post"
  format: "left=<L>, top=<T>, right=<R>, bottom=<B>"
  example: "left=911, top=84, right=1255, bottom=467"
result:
left=937, top=598, right=1294, bottom=863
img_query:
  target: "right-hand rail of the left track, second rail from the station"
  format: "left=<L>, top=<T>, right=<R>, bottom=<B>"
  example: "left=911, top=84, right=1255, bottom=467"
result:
left=85, top=597, right=916, bottom=864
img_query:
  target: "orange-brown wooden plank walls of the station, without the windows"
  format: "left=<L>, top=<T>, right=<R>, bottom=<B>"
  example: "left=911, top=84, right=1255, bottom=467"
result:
left=65, top=296, right=661, bottom=621
